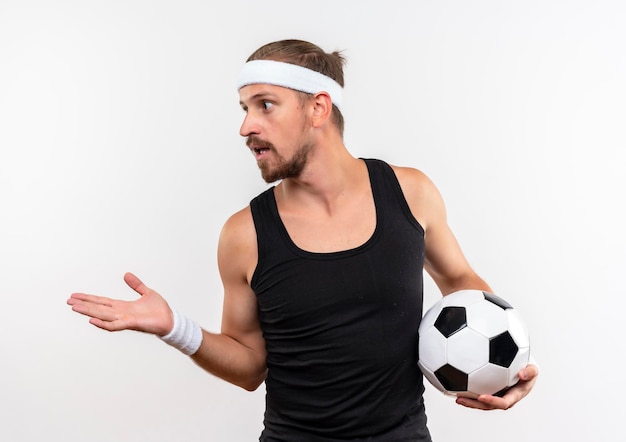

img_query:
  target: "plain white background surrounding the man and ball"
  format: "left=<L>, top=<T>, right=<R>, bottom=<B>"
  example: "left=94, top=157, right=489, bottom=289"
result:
left=0, top=0, right=626, bottom=442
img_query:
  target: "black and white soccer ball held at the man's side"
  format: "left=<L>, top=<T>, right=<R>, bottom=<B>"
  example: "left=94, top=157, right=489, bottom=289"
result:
left=418, top=290, right=530, bottom=398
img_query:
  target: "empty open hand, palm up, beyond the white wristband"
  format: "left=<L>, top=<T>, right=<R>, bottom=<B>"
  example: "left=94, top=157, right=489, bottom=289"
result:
left=67, top=273, right=174, bottom=336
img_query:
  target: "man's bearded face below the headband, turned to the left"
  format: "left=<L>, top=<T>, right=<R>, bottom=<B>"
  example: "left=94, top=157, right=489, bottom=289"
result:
left=239, top=84, right=312, bottom=183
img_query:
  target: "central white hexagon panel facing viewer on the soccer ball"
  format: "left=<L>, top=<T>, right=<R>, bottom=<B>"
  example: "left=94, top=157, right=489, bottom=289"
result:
left=448, top=327, right=489, bottom=373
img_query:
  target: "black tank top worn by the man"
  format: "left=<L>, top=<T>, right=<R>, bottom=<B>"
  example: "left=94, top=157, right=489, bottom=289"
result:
left=250, top=160, right=430, bottom=441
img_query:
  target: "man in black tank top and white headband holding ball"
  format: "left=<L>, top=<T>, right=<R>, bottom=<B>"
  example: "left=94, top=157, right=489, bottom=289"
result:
left=68, top=40, right=538, bottom=441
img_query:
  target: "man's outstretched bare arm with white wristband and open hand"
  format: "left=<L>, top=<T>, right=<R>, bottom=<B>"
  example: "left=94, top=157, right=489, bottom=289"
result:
left=67, top=207, right=267, bottom=390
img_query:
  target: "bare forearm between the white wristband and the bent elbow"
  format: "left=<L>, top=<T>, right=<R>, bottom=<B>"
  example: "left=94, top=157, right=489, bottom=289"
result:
left=191, top=330, right=267, bottom=391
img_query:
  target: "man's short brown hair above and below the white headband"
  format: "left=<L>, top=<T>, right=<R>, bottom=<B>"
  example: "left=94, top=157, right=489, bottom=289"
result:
left=247, top=39, right=346, bottom=136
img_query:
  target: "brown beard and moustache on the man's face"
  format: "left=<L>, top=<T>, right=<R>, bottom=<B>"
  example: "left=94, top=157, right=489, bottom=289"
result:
left=246, top=135, right=313, bottom=184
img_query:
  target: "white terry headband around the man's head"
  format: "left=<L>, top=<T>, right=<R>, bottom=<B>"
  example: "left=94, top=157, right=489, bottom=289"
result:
left=237, top=60, right=342, bottom=109
